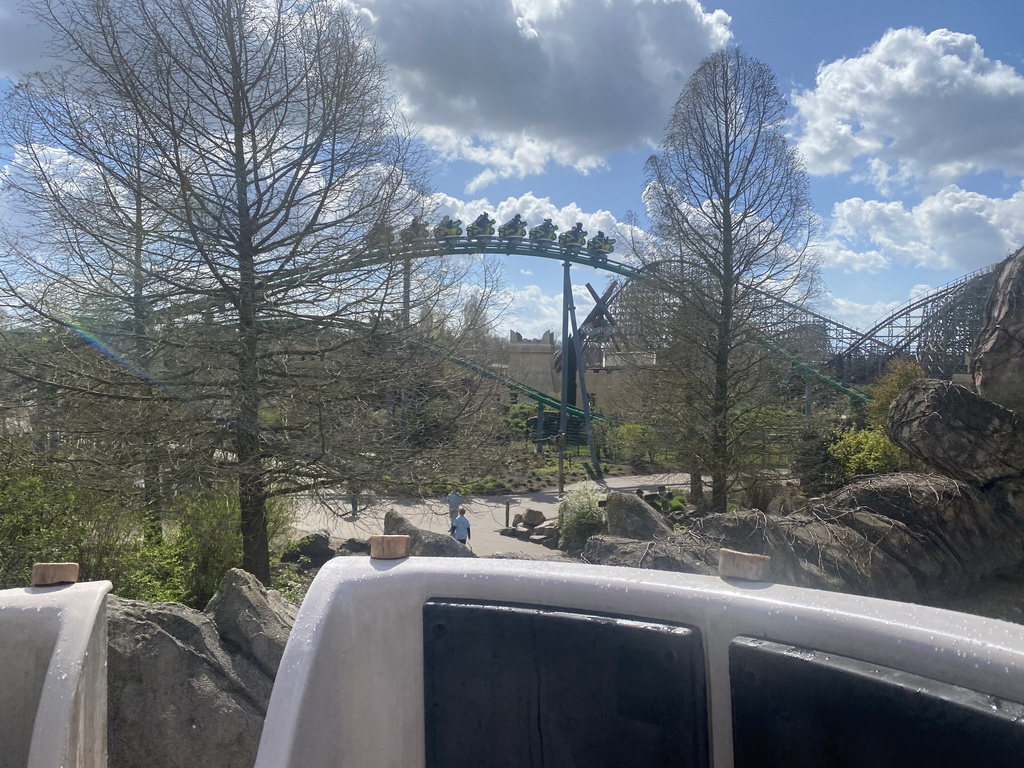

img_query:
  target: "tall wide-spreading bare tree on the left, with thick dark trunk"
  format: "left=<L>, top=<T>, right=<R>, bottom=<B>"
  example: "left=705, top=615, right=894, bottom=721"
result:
left=4, top=0, right=503, bottom=583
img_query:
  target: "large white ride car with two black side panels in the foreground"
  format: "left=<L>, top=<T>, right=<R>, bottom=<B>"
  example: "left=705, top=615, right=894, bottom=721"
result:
left=256, top=561, right=1024, bottom=768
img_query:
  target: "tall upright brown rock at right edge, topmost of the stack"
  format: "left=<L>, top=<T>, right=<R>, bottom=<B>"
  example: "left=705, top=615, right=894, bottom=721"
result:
left=971, top=248, right=1024, bottom=413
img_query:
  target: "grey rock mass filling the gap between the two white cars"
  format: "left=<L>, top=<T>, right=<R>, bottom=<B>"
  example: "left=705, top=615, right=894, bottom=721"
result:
left=108, top=571, right=298, bottom=768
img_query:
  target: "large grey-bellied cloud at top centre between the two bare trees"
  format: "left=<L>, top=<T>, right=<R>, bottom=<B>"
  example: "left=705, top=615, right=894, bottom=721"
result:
left=348, top=0, right=731, bottom=195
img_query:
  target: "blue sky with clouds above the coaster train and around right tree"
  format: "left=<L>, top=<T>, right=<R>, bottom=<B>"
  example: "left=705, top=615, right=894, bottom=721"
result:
left=0, top=0, right=1024, bottom=338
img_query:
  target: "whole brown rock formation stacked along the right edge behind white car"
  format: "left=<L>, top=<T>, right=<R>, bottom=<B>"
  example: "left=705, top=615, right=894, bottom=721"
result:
left=583, top=243, right=1024, bottom=601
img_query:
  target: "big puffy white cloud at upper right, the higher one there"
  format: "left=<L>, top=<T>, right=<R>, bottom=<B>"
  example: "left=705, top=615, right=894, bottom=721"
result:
left=793, top=28, right=1024, bottom=195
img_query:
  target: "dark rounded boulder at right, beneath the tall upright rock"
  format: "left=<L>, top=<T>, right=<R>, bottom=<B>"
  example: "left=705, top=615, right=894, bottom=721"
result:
left=886, top=379, right=1024, bottom=485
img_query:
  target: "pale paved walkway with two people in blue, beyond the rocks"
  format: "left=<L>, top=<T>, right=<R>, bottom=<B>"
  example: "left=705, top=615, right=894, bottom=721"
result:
left=295, top=474, right=689, bottom=556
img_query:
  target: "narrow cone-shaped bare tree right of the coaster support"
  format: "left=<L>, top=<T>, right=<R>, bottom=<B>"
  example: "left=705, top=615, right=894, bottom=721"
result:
left=635, top=48, right=817, bottom=518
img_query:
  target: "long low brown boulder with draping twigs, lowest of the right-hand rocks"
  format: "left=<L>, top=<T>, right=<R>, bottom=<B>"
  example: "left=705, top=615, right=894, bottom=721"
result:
left=583, top=473, right=1024, bottom=600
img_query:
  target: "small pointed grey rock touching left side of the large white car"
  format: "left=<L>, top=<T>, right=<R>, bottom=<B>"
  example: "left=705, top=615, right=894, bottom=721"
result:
left=203, top=568, right=298, bottom=678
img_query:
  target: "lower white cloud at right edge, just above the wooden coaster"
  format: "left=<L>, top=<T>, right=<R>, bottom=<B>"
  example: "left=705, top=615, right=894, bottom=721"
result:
left=822, top=185, right=1024, bottom=272
